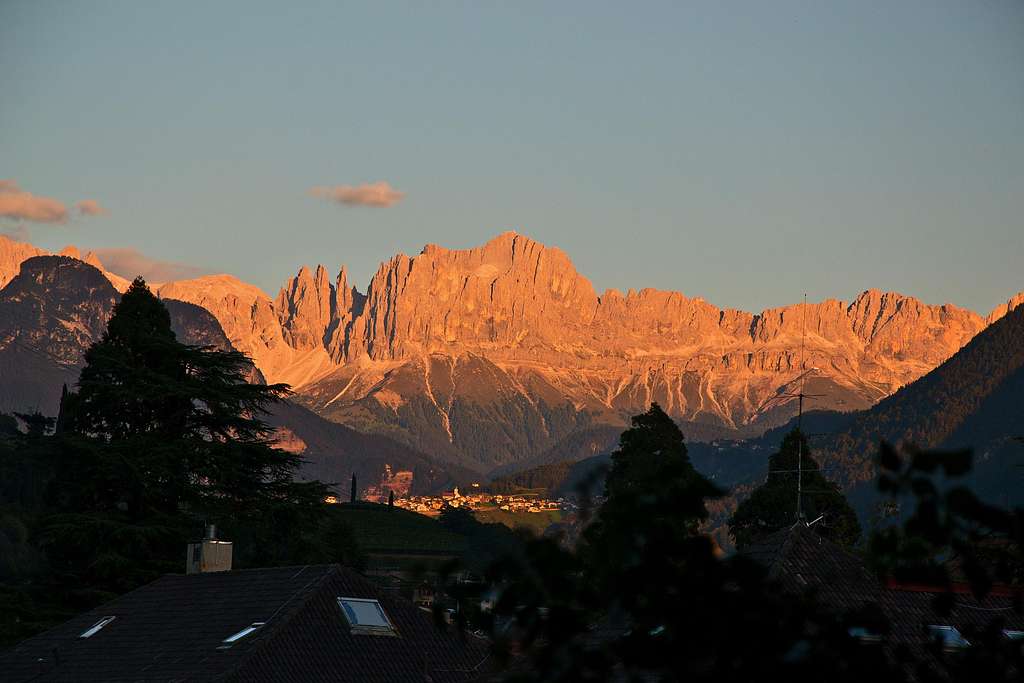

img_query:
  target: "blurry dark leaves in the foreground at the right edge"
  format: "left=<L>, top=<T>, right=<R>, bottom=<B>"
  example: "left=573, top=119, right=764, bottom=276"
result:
left=869, top=442, right=1024, bottom=681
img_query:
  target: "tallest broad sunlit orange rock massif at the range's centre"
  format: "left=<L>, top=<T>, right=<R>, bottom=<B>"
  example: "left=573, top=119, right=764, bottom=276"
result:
left=346, top=232, right=597, bottom=359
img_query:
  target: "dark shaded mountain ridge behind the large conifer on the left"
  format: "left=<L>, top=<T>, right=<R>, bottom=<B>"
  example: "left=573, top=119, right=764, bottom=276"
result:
left=0, top=245, right=474, bottom=495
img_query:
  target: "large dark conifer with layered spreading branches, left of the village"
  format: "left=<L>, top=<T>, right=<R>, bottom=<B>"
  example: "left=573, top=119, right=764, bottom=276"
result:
left=46, top=279, right=326, bottom=592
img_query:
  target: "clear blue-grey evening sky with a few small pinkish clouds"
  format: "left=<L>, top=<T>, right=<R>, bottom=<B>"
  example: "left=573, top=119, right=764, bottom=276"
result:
left=0, top=0, right=1024, bottom=312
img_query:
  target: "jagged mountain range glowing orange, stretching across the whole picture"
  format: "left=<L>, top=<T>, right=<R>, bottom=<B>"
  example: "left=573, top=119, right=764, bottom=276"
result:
left=0, top=232, right=1024, bottom=474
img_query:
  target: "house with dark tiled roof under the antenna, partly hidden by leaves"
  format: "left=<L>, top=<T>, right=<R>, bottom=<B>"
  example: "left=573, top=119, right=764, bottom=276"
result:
left=742, top=523, right=1024, bottom=659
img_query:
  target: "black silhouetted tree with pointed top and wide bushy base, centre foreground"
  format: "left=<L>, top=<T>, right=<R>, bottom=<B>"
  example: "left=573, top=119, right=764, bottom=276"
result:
left=475, top=404, right=900, bottom=681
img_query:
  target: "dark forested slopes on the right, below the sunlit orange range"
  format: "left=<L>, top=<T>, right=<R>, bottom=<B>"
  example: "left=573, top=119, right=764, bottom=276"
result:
left=499, top=305, right=1024, bottom=532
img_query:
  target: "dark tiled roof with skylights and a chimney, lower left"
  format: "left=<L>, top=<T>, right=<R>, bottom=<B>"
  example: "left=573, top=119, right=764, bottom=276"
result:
left=0, top=565, right=488, bottom=682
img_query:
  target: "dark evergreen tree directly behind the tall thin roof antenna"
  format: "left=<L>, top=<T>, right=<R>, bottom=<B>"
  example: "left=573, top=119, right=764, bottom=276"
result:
left=729, top=429, right=860, bottom=549
